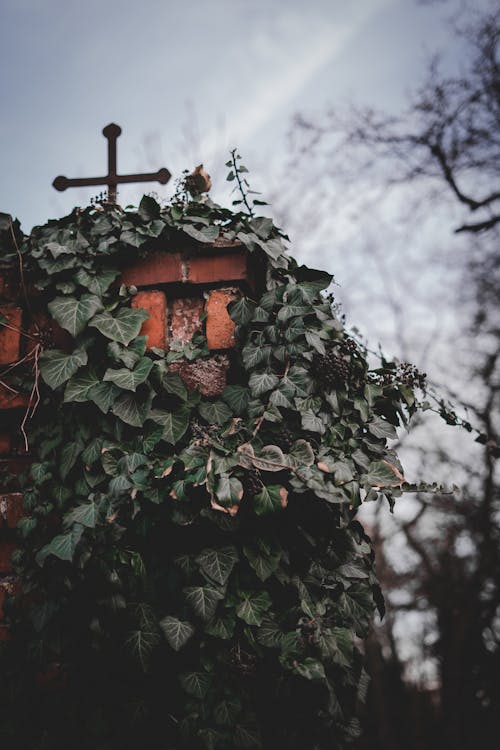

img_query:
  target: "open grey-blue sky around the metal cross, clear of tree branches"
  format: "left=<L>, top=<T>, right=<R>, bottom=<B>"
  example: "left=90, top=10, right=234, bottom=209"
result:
left=0, top=0, right=476, bottom=232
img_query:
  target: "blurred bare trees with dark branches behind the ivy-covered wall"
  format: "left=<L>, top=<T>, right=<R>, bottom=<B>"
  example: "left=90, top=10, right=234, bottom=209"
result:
left=273, top=6, right=500, bottom=750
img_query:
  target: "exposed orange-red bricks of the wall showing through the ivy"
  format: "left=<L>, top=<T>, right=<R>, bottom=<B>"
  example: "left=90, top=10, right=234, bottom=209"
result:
left=0, top=240, right=258, bottom=640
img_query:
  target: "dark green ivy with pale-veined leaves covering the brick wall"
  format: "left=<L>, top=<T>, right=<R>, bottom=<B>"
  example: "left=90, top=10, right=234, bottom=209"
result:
left=0, top=167, right=450, bottom=750
